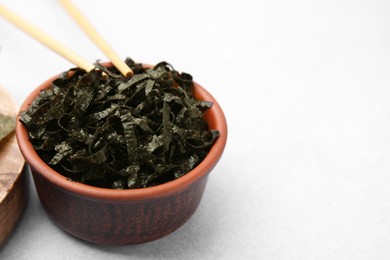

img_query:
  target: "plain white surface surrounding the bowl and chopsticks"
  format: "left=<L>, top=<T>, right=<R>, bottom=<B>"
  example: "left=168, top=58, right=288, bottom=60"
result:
left=0, top=0, right=390, bottom=260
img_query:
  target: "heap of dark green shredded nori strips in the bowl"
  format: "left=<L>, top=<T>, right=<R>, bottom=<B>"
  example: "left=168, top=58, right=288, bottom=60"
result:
left=20, top=59, right=219, bottom=189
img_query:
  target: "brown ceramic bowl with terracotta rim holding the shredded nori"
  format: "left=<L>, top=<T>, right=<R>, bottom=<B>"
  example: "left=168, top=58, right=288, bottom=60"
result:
left=16, top=64, right=227, bottom=245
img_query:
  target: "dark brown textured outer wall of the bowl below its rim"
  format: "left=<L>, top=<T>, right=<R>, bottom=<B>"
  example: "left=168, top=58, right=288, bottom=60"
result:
left=32, top=164, right=207, bottom=245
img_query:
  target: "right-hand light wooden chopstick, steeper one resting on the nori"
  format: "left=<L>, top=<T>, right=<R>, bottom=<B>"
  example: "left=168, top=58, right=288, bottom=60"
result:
left=59, top=0, right=133, bottom=77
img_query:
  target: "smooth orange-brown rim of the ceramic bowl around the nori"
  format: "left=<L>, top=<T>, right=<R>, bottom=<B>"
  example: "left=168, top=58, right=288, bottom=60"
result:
left=15, top=63, right=227, bottom=201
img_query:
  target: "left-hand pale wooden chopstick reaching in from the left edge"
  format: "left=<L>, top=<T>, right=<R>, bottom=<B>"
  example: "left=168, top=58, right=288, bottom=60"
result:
left=0, top=4, right=95, bottom=71
